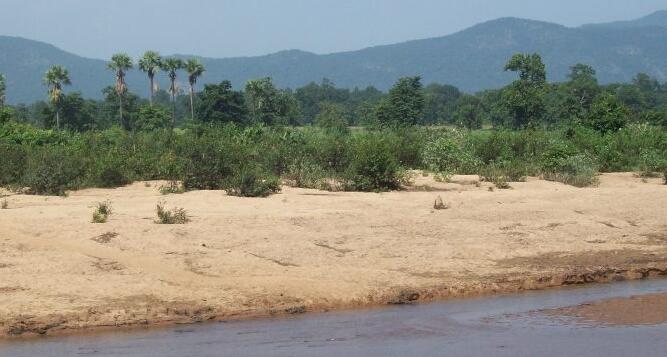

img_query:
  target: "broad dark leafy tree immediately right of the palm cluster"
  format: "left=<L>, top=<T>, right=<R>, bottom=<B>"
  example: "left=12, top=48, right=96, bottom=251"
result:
left=197, top=81, right=247, bottom=123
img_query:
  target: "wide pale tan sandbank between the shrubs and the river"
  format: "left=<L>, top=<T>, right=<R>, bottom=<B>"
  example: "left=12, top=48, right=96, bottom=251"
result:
left=0, top=173, right=667, bottom=335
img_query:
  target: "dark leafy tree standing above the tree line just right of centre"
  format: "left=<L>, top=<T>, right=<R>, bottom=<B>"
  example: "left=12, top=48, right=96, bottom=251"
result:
left=376, top=77, right=424, bottom=127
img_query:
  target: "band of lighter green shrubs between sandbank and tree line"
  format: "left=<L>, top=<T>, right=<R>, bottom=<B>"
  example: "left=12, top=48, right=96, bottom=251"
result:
left=0, top=122, right=667, bottom=196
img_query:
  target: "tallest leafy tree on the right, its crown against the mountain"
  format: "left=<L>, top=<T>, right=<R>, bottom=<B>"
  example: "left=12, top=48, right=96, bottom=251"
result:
left=503, top=53, right=547, bottom=128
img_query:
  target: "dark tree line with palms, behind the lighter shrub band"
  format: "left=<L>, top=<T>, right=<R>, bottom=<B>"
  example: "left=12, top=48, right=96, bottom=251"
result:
left=0, top=51, right=667, bottom=132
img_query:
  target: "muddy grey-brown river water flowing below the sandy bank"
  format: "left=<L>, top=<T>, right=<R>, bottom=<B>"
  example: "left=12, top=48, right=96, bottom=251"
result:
left=0, top=280, right=667, bottom=357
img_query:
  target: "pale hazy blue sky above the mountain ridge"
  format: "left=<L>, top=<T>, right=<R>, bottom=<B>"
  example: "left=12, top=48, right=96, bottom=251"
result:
left=0, top=0, right=667, bottom=58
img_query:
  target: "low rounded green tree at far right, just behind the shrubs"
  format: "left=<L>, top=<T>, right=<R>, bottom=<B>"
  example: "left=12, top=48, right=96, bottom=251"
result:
left=584, top=94, right=629, bottom=134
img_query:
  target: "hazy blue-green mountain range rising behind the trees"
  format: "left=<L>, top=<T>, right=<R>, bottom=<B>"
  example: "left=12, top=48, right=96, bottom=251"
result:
left=0, top=11, right=667, bottom=103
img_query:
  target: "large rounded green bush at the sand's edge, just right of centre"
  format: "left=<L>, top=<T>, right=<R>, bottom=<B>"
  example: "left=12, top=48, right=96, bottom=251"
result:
left=345, top=132, right=403, bottom=191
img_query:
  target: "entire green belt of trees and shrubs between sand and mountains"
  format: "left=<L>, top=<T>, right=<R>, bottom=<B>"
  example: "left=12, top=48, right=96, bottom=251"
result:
left=0, top=52, right=667, bottom=197
